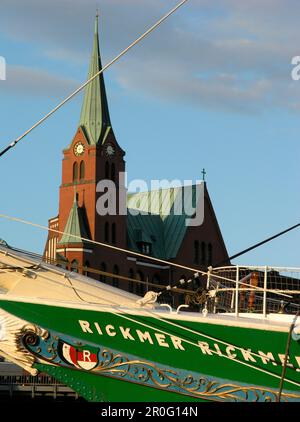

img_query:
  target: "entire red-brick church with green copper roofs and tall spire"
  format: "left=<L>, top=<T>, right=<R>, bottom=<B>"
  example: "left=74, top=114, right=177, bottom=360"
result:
left=44, top=16, right=229, bottom=302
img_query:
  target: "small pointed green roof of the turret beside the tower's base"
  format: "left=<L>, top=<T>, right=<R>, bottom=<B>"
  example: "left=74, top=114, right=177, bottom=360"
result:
left=59, top=197, right=88, bottom=244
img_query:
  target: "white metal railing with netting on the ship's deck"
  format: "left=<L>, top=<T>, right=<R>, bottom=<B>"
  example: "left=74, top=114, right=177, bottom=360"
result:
left=206, top=266, right=300, bottom=316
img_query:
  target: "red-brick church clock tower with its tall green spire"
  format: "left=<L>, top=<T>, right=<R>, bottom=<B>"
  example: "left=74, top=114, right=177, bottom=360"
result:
left=45, top=15, right=126, bottom=278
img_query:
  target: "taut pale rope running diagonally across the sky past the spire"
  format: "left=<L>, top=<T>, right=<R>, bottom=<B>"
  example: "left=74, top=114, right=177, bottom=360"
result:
left=0, top=0, right=188, bottom=157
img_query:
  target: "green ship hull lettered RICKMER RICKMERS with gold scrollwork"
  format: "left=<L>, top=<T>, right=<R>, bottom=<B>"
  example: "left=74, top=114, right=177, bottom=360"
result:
left=0, top=300, right=300, bottom=402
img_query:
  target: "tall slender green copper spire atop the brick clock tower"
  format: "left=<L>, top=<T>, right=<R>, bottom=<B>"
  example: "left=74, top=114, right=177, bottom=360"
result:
left=79, top=15, right=111, bottom=145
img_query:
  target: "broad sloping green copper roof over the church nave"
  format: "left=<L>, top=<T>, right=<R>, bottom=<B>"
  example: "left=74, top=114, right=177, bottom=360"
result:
left=127, top=185, right=202, bottom=259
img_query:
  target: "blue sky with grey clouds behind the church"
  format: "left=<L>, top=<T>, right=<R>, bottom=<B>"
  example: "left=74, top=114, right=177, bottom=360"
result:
left=0, top=0, right=300, bottom=267
